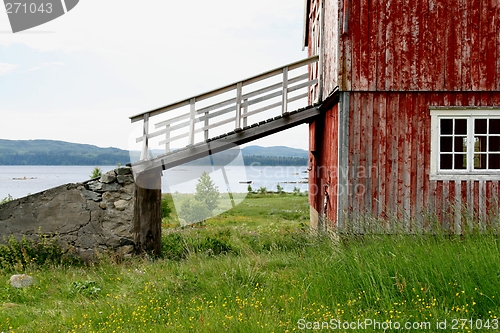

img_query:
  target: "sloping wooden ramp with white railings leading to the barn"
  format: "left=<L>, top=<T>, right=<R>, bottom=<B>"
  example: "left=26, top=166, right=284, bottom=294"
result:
left=130, top=56, right=320, bottom=174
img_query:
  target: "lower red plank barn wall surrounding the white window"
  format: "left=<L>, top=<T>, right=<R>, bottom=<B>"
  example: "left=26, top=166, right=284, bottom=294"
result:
left=346, top=92, right=500, bottom=232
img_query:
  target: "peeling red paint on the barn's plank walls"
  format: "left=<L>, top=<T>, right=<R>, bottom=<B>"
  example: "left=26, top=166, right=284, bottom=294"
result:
left=309, top=0, right=500, bottom=232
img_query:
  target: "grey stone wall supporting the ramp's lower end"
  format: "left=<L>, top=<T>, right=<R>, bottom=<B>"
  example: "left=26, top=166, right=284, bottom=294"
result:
left=0, top=167, right=139, bottom=259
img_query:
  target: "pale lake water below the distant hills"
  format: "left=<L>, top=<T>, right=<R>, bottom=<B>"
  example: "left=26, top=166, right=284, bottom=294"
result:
left=0, top=165, right=307, bottom=200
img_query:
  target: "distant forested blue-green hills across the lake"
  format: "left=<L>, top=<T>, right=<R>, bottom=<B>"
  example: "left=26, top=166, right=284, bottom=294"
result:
left=0, top=139, right=308, bottom=166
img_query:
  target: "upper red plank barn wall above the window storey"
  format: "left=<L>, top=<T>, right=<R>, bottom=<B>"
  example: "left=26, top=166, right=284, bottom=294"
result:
left=340, top=0, right=500, bottom=91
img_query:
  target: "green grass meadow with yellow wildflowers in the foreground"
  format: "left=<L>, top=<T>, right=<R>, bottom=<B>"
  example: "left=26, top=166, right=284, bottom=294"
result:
left=0, top=195, right=500, bottom=332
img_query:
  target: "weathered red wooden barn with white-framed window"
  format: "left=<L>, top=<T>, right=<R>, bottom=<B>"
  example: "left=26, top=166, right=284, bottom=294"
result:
left=304, top=0, right=500, bottom=233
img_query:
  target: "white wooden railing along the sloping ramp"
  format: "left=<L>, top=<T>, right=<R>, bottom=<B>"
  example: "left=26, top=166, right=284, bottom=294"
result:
left=130, top=56, right=318, bottom=160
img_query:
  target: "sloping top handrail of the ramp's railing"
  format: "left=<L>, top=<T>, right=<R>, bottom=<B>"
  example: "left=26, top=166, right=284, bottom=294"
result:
left=130, top=55, right=319, bottom=123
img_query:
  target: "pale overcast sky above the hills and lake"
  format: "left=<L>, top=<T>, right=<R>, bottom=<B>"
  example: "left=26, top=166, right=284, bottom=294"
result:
left=0, top=0, right=308, bottom=149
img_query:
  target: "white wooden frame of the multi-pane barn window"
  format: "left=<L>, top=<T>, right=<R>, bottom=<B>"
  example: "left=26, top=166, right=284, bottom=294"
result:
left=429, top=107, right=500, bottom=180
